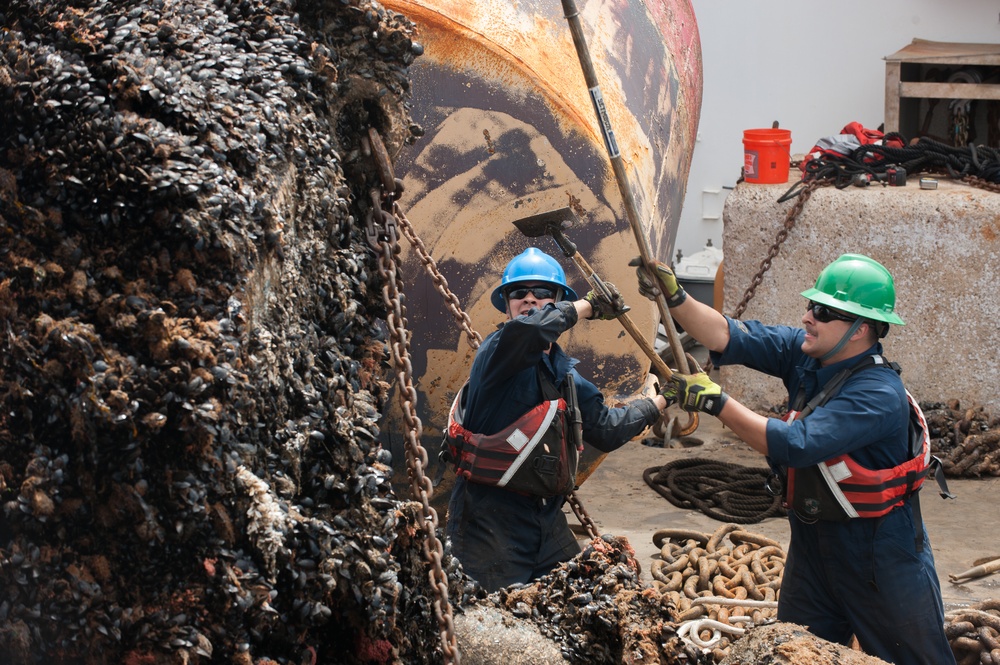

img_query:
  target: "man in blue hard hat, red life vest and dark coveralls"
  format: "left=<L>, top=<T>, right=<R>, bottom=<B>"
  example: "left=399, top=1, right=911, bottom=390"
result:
left=444, top=247, right=667, bottom=592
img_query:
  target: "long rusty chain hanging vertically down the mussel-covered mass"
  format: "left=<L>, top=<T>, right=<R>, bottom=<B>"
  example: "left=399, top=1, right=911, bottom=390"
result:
left=366, top=129, right=461, bottom=665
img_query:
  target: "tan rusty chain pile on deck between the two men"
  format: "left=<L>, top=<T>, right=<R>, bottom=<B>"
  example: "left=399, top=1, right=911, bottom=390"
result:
left=650, top=524, right=785, bottom=662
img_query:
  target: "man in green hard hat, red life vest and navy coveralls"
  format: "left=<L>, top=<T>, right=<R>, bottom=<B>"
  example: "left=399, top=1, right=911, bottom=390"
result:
left=637, top=254, right=955, bottom=665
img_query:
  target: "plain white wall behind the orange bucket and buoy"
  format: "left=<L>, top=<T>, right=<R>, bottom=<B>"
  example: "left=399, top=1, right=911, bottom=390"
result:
left=671, top=0, right=1000, bottom=259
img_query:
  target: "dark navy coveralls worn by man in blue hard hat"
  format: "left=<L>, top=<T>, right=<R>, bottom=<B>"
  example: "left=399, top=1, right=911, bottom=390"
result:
left=446, top=301, right=660, bottom=592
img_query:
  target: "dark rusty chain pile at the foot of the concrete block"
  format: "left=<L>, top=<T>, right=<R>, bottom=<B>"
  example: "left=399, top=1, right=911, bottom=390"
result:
left=920, top=400, right=1000, bottom=478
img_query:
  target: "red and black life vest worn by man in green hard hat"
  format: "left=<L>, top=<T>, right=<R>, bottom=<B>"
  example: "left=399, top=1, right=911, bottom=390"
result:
left=783, top=356, right=947, bottom=521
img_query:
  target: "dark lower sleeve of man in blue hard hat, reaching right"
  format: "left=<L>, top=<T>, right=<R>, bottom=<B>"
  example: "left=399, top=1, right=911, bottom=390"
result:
left=573, top=370, right=660, bottom=453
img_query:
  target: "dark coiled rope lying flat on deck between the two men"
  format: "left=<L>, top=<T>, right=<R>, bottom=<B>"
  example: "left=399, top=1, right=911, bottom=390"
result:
left=642, top=457, right=785, bottom=524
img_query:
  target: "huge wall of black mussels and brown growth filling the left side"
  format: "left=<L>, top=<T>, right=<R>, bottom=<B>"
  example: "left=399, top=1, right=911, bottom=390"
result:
left=0, top=0, right=475, bottom=665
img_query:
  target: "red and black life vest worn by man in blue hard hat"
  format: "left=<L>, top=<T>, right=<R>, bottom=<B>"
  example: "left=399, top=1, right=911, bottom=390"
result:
left=444, top=376, right=583, bottom=497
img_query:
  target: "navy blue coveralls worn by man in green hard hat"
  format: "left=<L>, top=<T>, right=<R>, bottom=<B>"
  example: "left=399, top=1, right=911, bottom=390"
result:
left=712, top=319, right=955, bottom=665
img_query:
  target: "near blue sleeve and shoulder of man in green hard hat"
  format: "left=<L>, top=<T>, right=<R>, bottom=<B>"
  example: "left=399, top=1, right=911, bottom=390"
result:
left=767, top=370, right=909, bottom=468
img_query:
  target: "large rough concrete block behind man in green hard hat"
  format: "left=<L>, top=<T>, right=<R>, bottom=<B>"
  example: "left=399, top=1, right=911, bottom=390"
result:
left=721, top=176, right=1000, bottom=414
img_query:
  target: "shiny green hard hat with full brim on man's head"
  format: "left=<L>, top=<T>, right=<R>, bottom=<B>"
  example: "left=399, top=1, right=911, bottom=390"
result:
left=802, top=254, right=903, bottom=325
